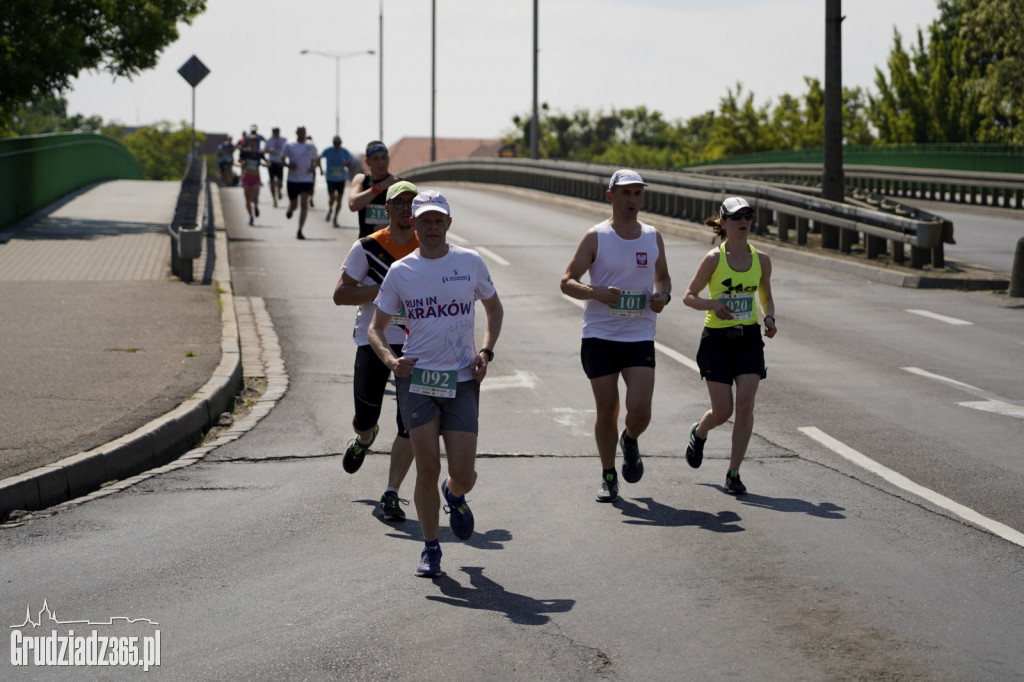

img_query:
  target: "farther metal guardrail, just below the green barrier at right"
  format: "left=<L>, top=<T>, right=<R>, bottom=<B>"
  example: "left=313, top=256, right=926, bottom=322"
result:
left=695, top=163, right=1024, bottom=209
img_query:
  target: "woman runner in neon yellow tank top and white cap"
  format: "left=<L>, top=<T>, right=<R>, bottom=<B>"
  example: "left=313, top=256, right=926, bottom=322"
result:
left=683, top=197, right=778, bottom=495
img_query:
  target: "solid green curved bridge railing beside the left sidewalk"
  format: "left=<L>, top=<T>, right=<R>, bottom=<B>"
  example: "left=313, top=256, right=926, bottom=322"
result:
left=0, top=133, right=142, bottom=229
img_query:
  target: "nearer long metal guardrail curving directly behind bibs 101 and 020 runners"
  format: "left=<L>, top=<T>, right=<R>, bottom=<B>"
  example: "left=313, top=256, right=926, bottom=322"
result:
left=402, top=159, right=952, bottom=268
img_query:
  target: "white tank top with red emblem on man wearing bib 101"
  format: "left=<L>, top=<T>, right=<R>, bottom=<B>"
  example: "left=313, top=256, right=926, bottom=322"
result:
left=583, top=220, right=660, bottom=342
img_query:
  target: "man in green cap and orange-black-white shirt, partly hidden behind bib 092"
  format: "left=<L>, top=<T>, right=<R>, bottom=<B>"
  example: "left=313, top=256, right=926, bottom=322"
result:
left=334, top=178, right=419, bottom=521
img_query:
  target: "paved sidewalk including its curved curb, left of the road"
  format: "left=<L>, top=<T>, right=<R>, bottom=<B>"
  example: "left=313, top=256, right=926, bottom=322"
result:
left=0, top=180, right=241, bottom=520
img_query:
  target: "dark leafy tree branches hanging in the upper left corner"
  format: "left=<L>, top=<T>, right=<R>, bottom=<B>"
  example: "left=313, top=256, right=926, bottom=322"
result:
left=0, top=0, right=206, bottom=119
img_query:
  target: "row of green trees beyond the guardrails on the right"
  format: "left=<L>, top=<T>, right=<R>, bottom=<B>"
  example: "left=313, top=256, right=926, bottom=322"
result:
left=505, top=0, right=1024, bottom=168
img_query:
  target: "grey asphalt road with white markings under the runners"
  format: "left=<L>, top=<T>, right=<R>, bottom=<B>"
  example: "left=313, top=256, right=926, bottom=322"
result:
left=0, top=186, right=1024, bottom=680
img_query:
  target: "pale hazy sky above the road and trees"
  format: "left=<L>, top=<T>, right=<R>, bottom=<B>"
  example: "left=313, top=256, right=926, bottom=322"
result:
left=68, top=0, right=938, bottom=151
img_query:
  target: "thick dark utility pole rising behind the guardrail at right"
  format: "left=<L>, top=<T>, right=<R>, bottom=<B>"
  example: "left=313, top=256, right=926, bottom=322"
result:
left=821, top=0, right=852, bottom=251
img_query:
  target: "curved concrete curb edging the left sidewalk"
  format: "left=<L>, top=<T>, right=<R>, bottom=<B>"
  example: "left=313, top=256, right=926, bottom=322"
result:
left=0, top=183, right=243, bottom=521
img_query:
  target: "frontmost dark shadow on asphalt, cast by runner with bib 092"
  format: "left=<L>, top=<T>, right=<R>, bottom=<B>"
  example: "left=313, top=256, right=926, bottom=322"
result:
left=427, top=566, right=575, bottom=626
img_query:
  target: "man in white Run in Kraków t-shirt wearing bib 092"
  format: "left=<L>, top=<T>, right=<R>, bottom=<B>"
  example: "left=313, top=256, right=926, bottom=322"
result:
left=369, top=190, right=504, bottom=578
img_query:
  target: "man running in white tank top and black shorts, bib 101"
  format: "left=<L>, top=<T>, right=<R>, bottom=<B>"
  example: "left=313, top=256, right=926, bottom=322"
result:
left=561, top=169, right=672, bottom=502
